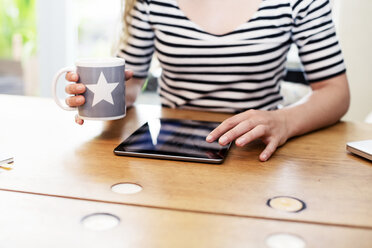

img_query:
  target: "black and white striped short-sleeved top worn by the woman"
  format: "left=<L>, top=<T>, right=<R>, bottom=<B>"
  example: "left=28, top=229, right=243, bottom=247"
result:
left=118, top=0, right=345, bottom=112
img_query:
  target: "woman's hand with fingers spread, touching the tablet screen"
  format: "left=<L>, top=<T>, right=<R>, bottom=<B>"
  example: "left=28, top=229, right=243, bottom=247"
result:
left=206, top=110, right=289, bottom=161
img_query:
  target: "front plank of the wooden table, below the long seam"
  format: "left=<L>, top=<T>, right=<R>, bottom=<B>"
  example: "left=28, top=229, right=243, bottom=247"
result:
left=0, top=191, right=372, bottom=248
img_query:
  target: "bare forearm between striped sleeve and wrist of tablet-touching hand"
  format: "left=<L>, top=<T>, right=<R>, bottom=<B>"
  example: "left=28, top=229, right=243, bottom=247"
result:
left=278, top=74, right=350, bottom=138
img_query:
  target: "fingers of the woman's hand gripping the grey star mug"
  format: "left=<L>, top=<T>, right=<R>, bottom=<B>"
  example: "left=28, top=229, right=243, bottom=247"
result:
left=65, top=70, right=133, bottom=125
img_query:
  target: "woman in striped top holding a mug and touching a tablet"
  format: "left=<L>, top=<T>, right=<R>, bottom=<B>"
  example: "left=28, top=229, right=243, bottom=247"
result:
left=66, top=0, right=350, bottom=161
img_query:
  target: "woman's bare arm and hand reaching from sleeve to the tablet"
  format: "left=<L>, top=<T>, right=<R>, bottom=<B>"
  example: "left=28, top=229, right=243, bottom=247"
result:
left=207, top=73, right=350, bottom=161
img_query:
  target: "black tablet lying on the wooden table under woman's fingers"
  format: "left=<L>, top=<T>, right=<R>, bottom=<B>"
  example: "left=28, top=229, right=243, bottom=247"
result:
left=114, top=119, right=231, bottom=164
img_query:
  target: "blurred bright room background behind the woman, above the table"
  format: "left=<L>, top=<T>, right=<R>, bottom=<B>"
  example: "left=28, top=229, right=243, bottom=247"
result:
left=0, top=0, right=372, bottom=123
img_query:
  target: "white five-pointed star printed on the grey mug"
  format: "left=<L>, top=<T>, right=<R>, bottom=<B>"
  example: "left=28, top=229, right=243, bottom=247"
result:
left=85, top=72, right=119, bottom=107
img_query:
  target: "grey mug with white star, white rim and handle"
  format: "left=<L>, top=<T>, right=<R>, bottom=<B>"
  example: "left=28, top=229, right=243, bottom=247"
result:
left=53, top=58, right=126, bottom=120
